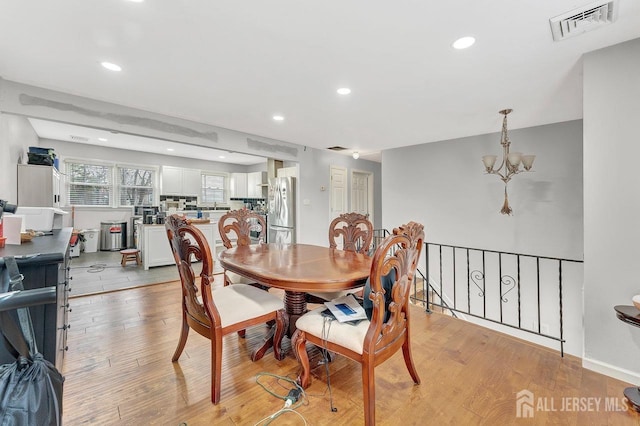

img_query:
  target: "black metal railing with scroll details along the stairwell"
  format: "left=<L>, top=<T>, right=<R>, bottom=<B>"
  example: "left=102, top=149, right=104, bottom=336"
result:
left=413, top=243, right=582, bottom=356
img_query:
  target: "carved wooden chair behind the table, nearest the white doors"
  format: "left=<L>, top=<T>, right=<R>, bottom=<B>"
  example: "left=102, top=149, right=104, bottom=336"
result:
left=306, top=212, right=373, bottom=304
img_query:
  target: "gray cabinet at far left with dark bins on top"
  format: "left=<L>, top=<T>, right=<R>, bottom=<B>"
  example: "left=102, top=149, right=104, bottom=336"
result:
left=17, top=164, right=61, bottom=207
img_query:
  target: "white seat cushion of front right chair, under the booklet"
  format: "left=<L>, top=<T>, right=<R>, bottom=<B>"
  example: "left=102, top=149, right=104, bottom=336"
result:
left=296, top=306, right=371, bottom=354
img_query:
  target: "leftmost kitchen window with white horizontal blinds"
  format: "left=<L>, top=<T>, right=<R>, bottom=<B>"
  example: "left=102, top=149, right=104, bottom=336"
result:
left=65, top=161, right=113, bottom=206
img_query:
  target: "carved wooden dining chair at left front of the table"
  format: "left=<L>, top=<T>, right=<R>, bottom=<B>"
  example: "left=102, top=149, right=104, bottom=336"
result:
left=165, top=214, right=285, bottom=404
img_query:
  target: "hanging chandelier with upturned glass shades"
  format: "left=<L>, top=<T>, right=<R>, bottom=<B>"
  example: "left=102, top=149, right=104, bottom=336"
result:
left=482, top=109, right=536, bottom=215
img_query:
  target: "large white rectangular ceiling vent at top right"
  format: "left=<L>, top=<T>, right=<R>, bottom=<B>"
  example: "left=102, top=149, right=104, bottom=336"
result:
left=549, top=0, right=618, bottom=41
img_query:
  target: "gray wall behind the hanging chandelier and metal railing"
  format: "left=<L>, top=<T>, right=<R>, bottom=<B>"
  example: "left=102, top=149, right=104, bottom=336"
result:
left=382, top=120, right=583, bottom=356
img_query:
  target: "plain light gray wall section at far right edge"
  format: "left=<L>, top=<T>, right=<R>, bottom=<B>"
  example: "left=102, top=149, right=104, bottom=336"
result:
left=584, top=39, right=640, bottom=382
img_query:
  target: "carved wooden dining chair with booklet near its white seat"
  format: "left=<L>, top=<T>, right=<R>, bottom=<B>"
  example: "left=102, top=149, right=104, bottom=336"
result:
left=292, top=222, right=424, bottom=425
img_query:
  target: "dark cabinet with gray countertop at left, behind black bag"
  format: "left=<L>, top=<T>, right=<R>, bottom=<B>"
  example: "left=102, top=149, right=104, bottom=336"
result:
left=0, top=228, right=71, bottom=371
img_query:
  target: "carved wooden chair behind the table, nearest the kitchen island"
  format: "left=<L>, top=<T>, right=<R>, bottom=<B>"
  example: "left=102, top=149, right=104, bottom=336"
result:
left=218, top=209, right=268, bottom=289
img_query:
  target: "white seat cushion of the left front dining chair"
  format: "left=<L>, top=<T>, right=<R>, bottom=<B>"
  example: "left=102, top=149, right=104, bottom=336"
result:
left=212, top=284, right=284, bottom=327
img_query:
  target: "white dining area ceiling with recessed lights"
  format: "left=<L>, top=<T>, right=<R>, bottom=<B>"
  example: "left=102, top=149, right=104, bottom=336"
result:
left=0, top=0, right=640, bottom=163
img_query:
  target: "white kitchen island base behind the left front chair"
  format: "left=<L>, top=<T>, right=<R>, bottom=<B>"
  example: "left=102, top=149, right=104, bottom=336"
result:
left=139, top=223, right=217, bottom=270
